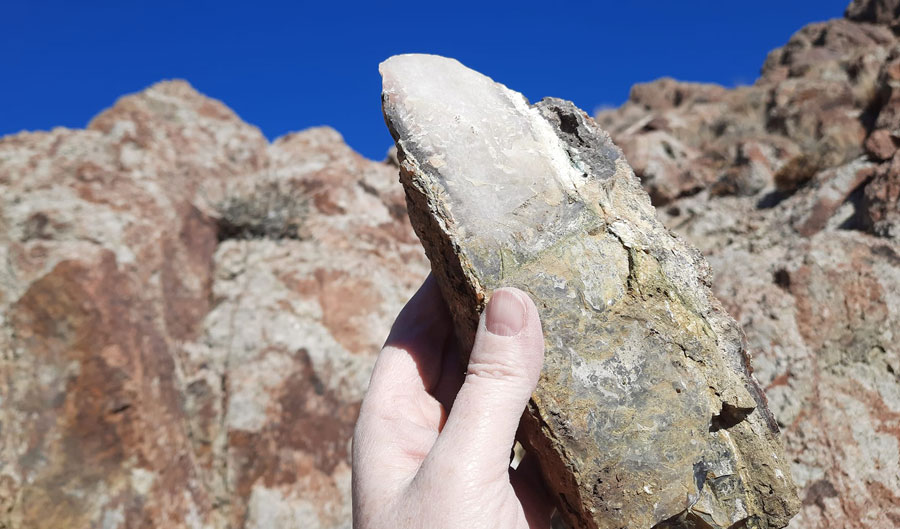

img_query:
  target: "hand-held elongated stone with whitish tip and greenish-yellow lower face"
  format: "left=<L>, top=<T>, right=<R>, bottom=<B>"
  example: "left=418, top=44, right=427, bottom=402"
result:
left=381, top=55, right=799, bottom=529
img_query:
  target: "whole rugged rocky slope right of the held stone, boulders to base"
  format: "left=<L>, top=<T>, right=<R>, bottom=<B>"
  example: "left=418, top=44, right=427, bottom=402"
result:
left=596, top=0, right=900, bottom=529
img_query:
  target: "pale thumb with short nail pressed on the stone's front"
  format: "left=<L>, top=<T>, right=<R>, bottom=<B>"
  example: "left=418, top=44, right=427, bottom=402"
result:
left=426, top=288, right=544, bottom=479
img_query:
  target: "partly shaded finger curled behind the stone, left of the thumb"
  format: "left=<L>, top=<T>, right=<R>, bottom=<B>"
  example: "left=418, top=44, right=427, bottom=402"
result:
left=353, top=276, right=450, bottom=498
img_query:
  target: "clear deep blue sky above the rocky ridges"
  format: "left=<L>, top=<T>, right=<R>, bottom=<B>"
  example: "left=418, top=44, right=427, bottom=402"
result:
left=0, top=0, right=849, bottom=159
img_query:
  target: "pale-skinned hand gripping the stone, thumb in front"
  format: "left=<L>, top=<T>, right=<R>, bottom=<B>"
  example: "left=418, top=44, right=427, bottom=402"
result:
left=353, top=277, right=552, bottom=529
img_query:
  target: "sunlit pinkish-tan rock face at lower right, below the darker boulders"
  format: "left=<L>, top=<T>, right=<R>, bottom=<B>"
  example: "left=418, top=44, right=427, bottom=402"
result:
left=709, top=229, right=900, bottom=529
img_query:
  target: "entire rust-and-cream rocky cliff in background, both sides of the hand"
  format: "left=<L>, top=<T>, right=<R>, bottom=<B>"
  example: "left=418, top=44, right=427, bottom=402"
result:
left=0, top=0, right=900, bottom=529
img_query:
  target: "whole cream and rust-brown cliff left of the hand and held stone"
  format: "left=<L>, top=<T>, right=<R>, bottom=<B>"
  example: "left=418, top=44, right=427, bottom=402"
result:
left=0, top=82, right=427, bottom=529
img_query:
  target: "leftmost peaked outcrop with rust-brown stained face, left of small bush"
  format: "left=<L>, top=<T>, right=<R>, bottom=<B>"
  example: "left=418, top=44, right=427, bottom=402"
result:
left=0, top=82, right=266, bottom=528
